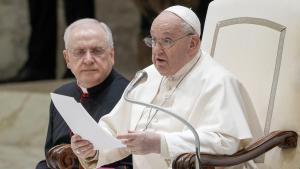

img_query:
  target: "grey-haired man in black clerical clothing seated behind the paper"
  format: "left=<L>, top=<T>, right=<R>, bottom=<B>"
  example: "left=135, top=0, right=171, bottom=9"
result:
left=36, top=19, right=131, bottom=169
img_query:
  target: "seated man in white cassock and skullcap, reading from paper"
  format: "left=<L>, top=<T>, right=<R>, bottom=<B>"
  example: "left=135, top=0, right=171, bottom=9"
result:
left=71, top=6, right=255, bottom=169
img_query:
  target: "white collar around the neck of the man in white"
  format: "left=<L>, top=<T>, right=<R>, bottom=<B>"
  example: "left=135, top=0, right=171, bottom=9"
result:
left=166, top=49, right=201, bottom=81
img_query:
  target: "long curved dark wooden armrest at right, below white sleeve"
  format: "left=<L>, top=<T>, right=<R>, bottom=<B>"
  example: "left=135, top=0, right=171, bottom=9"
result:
left=172, top=131, right=298, bottom=169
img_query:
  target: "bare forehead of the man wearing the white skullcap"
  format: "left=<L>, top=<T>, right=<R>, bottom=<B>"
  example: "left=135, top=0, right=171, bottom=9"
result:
left=150, top=11, right=183, bottom=36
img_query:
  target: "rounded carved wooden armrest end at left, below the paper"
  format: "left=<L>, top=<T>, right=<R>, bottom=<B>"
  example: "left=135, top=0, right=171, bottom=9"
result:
left=46, top=144, right=82, bottom=169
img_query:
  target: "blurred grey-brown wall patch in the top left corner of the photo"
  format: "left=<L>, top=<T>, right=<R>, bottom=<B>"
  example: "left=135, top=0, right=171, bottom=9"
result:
left=0, top=0, right=29, bottom=79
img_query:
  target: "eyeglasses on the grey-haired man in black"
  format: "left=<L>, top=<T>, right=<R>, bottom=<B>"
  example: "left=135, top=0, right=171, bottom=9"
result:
left=67, top=47, right=107, bottom=59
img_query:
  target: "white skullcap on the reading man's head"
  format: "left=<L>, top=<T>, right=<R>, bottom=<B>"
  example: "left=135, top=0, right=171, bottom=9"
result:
left=164, top=5, right=201, bottom=36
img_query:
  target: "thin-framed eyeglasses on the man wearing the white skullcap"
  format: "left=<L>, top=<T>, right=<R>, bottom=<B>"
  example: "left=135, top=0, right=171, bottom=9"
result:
left=144, top=33, right=193, bottom=49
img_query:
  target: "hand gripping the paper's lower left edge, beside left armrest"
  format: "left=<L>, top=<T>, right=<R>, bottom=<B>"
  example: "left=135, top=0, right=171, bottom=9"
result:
left=71, top=134, right=97, bottom=159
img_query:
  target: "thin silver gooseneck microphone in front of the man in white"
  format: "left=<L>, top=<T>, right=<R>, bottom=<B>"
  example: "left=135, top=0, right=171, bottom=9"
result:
left=123, top=70, right=201, bottom=169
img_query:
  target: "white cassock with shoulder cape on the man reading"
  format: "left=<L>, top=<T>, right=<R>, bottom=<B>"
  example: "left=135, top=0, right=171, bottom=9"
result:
left=80, top=49, right=260, bottom=169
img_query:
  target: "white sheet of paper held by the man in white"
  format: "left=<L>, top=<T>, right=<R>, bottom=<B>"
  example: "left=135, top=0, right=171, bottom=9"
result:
left=50, top=93, right=125, bottom=150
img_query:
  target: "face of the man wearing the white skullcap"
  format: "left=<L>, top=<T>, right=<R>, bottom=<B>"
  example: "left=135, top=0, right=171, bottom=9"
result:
left=150, top=12, right=192, bottom=76
